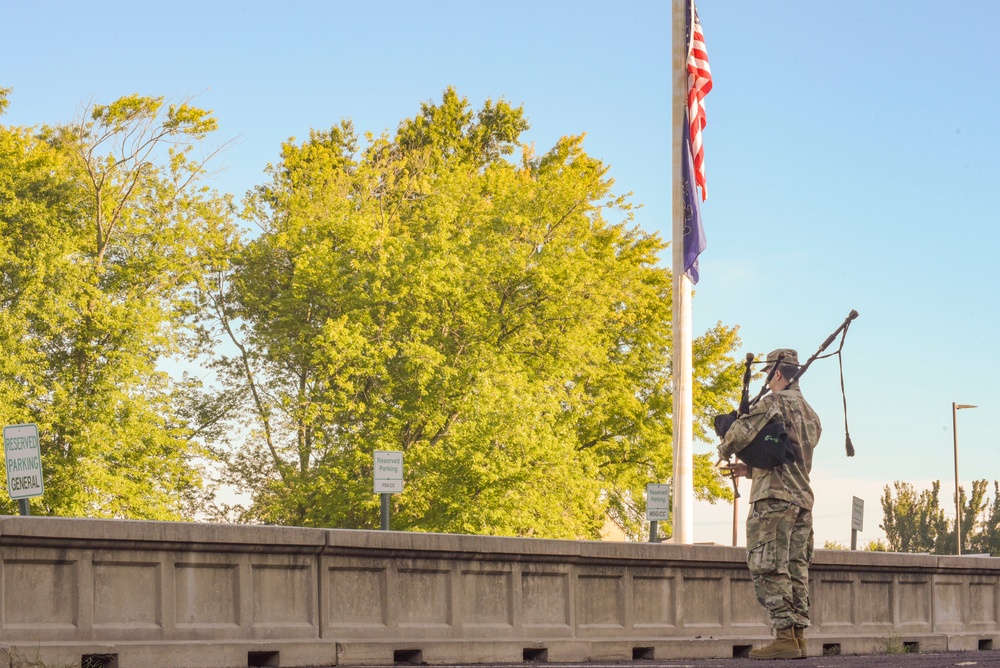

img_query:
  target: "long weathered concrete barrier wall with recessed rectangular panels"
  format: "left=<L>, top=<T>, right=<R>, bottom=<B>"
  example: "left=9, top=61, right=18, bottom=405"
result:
left=0, top=517, right=1000, bottom=668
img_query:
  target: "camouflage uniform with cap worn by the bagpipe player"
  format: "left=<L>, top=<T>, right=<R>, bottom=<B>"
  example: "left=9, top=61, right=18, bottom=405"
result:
left=719, top=349, right=822, bottom=631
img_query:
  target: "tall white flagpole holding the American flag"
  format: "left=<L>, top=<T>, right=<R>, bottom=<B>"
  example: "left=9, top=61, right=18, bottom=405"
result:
left=671, top=0, right=694, bottom=545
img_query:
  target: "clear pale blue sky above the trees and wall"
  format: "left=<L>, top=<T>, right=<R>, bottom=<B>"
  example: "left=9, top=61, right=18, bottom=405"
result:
left=0, top=0, right=1000, bottom=545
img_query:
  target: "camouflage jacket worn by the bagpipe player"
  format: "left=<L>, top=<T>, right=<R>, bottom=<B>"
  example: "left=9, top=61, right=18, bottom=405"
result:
left=719, top=383, right=823, bottom=510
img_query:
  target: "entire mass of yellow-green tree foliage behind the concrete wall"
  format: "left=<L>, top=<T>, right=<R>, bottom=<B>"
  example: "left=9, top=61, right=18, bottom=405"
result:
left=0, top=89, right=739, bottom=538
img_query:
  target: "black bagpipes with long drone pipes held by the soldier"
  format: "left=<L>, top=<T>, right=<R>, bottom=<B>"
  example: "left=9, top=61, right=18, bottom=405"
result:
left=713, top=310, right=858, bottom=490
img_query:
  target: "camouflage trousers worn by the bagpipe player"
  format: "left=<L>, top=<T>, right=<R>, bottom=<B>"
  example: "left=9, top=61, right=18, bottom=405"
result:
left=747, top=499, right=813, bottom=631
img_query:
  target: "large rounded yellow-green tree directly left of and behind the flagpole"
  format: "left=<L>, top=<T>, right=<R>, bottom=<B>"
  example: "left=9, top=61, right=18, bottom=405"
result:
left=213, top=89, right=739, bottom=538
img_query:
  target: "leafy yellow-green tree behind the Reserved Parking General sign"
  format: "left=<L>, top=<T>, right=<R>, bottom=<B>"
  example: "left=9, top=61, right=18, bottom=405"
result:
left=0, top=96, right=232, bottom=519
